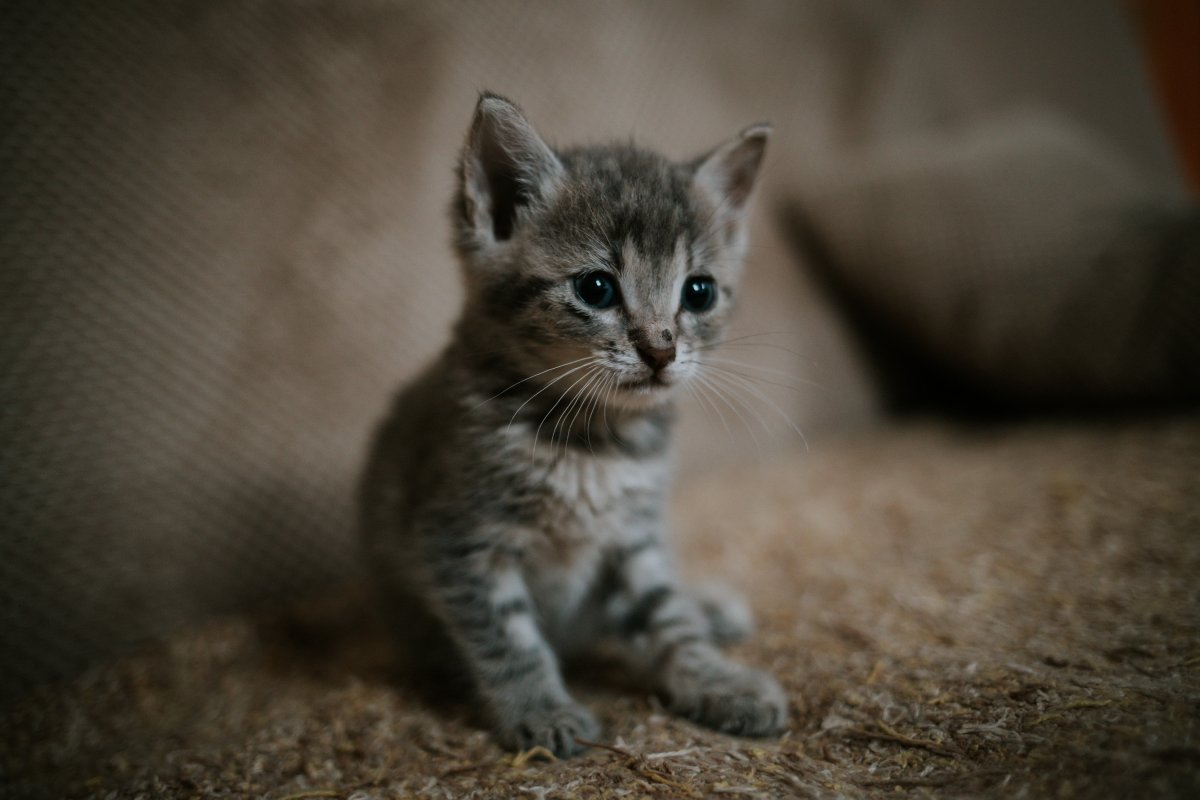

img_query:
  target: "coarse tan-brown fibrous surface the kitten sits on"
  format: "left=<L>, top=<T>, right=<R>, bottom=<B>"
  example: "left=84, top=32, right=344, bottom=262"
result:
left=0, top=416, right=1200, bottom=800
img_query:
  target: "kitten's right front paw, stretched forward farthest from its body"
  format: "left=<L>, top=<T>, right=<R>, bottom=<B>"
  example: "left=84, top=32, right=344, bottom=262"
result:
left=662, top=658, right=787, bottom=736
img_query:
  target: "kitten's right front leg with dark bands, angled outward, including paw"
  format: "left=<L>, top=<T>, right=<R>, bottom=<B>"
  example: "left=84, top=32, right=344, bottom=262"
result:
left=608, top=536, right=787, bottom=736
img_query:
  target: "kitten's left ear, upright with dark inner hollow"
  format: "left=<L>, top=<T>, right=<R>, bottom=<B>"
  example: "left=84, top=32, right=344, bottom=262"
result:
left=458, top=92, right=563, bottom=243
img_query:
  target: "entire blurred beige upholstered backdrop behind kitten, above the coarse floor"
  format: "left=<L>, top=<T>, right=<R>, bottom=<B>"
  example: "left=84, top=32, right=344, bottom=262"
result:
left=0, top=0, right=1200, bottom=699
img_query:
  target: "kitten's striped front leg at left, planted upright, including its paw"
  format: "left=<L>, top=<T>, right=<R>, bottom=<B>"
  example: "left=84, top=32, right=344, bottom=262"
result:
left=434, top=546, right=600, bottom=757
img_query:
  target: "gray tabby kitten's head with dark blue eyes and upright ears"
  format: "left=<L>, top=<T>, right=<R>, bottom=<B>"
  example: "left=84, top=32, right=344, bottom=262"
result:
left=454, top=94, right=770, bottom=408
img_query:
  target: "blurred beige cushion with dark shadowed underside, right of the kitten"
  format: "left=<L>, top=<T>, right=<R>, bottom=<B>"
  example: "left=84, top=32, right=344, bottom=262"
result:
left=793, top=110, right=1200, bottom=410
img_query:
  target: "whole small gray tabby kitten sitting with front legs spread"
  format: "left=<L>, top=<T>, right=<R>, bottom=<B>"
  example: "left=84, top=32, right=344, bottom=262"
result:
left=361, top=94, right=787, bottom=756
